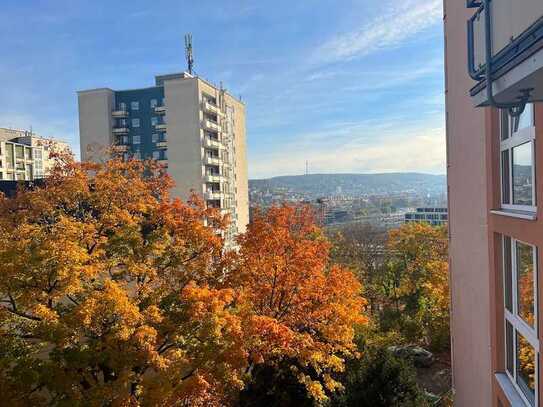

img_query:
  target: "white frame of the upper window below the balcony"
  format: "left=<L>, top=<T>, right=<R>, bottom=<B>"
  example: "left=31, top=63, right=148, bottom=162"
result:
left=499, top=104, right=537, bottom=212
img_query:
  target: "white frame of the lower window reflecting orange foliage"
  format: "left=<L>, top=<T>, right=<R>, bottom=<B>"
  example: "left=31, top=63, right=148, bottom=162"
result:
left=502, top=236, right=539, bottom=407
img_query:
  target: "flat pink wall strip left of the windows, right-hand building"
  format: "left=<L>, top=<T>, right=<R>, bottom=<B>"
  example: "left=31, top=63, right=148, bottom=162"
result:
left=444, top=0, right=493, bottom=407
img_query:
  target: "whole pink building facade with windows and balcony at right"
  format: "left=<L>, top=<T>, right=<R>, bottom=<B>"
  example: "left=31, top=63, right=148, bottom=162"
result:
left=444, top=0, right=543, bottom=407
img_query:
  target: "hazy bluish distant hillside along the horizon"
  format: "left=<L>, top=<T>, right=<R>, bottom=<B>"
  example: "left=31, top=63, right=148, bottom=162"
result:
left=249, top=173, right=446, bottom=197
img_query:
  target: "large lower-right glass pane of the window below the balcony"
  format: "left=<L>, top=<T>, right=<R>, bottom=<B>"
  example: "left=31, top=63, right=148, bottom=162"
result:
left=513, top=142, right=534, bottom=206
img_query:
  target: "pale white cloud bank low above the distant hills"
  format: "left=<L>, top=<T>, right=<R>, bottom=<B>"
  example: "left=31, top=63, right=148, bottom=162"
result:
left=249, top=115, right=446, bottom=178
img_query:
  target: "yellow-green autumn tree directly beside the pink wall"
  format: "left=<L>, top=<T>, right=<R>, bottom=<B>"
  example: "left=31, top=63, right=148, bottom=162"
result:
left=382, top=223, right=450, bottom=350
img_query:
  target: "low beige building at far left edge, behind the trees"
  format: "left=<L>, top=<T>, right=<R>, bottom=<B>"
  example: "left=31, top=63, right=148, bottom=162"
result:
left=0, top=128, right=70, bottom=181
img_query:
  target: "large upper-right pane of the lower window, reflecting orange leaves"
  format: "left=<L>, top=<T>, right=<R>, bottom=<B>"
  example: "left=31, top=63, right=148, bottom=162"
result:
left=516, top=242, right=535, bottom=328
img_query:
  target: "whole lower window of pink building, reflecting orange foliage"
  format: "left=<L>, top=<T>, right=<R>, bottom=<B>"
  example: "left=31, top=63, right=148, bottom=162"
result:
left=503, top=236, right=539, bottom=406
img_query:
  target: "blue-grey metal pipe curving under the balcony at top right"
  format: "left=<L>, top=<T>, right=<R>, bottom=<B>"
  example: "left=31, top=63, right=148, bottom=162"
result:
left=483, top=0, right=533, bottom=127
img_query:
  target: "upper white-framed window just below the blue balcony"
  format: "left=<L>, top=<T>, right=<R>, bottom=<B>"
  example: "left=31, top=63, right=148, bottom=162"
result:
left=500, top=104, right=536, bottom=212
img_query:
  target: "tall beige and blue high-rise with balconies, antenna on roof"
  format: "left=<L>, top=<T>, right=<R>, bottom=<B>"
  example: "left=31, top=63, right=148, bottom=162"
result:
left=78, top=73, right=249, bottom=236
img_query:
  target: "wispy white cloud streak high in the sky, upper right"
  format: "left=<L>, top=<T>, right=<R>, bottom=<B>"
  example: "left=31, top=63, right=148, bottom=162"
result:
left=315, top=0, right=442, bottom=63
